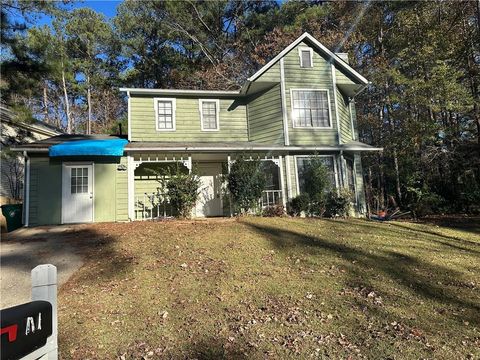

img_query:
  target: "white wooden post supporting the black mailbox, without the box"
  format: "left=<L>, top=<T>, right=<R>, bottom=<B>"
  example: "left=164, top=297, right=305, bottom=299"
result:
left=32, top=264, right=58, bottom=360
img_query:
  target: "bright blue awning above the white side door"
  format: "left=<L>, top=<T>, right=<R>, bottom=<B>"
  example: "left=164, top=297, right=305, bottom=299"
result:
left=48, top=139, right=128, bottom=157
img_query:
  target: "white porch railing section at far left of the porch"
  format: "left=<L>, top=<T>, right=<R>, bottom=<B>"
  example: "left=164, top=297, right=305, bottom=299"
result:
left=135, top=192, right=173, bottom=220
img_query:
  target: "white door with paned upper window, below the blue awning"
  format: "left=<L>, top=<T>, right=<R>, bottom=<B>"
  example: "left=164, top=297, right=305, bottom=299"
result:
left=62, top=164, right=93, bottom=223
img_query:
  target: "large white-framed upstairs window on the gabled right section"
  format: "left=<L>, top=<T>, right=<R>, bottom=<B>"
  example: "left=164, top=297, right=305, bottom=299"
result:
left=290, top=89, right=332, bottom=128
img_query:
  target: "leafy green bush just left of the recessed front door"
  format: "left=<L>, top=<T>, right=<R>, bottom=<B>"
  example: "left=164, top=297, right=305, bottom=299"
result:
left=166, top=171, right=200, bottom=218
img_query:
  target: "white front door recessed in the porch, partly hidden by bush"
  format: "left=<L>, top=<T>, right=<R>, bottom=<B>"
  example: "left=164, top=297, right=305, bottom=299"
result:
left=195, top=163, right=223, bottom=217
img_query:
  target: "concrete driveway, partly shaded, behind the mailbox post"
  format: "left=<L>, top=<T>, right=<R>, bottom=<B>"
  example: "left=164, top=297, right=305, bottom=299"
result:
left=0, top=225, right=83, bottom=308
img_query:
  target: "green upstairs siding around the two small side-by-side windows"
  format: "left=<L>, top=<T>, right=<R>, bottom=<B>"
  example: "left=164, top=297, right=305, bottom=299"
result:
left=130, top=96, right=248, bottom=141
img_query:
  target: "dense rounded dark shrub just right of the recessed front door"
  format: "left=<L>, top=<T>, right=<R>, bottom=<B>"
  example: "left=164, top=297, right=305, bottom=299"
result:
left=227, top=157, right=266, bottom=213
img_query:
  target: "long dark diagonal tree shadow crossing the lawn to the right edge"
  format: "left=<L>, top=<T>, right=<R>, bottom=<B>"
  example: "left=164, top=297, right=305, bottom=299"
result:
left=244, top=222, right=480, bottom=324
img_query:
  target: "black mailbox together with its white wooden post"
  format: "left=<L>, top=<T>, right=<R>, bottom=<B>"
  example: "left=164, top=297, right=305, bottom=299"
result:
left=0, top=264, right=58, bottom=360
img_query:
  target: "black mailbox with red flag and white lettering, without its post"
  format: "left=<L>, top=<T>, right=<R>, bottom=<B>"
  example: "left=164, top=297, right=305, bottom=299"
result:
left=0, top=301, right=52, bottom=360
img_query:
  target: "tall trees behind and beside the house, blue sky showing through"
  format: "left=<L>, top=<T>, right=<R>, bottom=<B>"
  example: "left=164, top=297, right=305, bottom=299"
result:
left=0, top=0, right=480, bottom=215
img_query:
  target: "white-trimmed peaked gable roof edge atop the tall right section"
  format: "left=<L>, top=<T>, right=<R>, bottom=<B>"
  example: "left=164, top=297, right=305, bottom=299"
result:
left=247, top=32, right=368, bottom=85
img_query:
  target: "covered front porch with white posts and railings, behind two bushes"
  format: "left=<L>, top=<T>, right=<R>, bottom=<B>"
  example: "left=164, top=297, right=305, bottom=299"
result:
left=128, top=153, right=287, bottom=220
